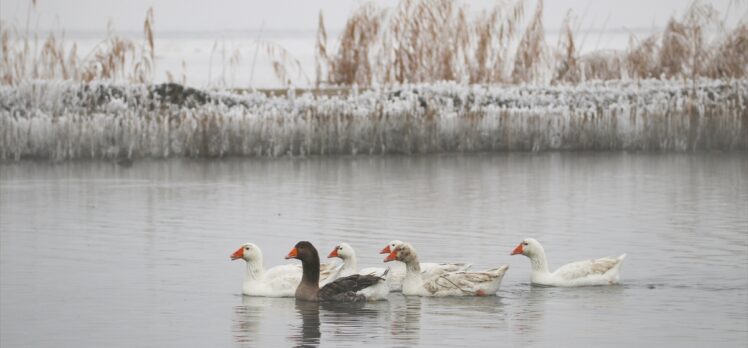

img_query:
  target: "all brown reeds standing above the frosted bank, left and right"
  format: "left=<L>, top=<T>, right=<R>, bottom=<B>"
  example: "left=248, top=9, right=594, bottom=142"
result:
left=0, top=0, right=748, bottom=87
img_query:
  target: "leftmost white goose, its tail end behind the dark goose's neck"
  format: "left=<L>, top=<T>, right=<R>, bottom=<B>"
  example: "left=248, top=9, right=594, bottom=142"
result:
left=231, top=243, right=339, bottom=297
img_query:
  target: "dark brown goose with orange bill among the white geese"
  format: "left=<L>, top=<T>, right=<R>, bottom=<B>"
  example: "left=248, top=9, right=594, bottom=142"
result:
left=286, top=242, right=389, bottom=302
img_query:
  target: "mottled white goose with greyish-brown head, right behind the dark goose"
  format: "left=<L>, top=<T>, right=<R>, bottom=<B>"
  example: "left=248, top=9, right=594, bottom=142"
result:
left=384, top=243, right=509, bottom=296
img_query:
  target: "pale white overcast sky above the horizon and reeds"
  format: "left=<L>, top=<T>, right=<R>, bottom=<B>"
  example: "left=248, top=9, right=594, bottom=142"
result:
left=0, top=0, right=748, bottom=32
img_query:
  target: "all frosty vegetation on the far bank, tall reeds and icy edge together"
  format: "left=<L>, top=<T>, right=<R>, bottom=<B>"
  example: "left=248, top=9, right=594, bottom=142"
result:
left=0, top=0, right=748, bottom=160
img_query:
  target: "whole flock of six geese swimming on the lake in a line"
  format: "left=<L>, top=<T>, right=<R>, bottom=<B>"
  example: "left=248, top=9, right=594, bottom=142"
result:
left=231, top=238, right=626, bottom=302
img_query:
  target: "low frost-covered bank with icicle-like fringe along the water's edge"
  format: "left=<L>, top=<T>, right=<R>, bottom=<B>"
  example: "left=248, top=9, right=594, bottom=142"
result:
left=0, top=80, right=748, bottom=160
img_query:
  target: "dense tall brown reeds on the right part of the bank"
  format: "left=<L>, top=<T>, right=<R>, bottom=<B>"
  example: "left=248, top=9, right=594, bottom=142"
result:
left=317, top=0, right=748, bottom=86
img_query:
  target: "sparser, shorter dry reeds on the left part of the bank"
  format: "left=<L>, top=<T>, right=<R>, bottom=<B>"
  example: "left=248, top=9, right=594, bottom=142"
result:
left=0, top=1, right=310, bottom=88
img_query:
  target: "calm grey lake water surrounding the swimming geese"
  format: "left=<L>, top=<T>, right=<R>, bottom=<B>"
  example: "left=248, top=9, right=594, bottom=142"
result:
left=0, top=153, right=748, bottom=347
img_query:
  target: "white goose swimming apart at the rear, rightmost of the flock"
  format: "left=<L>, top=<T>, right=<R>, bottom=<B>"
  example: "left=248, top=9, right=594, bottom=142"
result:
left=512, top=238, right=626, bottom=286
